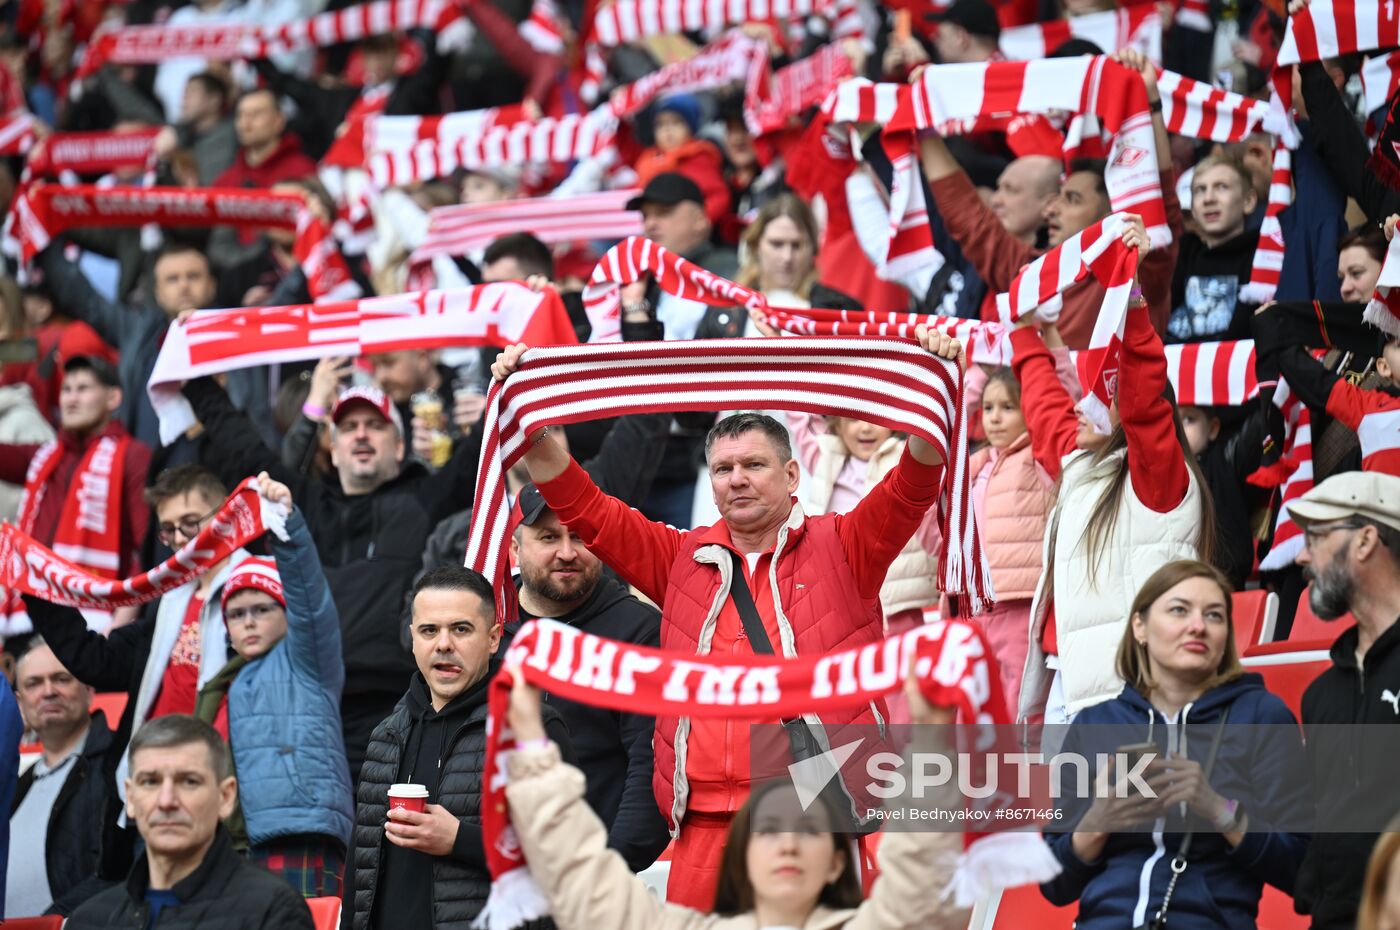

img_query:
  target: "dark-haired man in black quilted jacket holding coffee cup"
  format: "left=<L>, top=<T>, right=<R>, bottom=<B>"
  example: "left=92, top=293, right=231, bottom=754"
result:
left=353, top=566, right=573, bottom=930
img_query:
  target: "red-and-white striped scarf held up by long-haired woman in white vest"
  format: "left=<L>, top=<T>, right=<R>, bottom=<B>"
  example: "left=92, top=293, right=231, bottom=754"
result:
left=997, top=213, right=1137, bottom=433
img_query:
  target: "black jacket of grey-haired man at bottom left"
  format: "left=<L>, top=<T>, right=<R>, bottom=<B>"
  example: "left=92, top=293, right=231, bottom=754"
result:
left=63, top=826, right=315, bottom=930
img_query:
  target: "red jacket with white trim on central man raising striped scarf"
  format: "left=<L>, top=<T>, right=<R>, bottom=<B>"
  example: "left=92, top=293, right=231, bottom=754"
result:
left=539, top=451, right=941, bottom=832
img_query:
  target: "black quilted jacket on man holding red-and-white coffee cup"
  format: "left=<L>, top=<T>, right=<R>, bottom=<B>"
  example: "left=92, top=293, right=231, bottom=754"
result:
left=355, top=664, right=573, bottom=930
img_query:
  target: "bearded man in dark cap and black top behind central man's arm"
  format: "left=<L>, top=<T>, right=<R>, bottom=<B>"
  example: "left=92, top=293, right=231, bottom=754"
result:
left=507, top=485, right=671, bottom=871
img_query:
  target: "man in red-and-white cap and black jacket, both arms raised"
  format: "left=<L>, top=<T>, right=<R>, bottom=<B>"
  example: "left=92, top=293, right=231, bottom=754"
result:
left=185, top=378, right=482, bottom=777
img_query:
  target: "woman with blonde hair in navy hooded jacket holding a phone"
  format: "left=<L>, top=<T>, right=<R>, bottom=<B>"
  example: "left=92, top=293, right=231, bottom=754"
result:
left=1042, top=560, right=1308, bottom=930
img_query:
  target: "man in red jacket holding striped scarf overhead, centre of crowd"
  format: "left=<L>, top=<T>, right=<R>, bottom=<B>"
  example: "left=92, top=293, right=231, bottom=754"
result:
left=491, top=332, right=960, bottom=910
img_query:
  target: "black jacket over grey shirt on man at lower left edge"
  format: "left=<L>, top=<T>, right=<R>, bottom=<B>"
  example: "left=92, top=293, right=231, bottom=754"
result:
left=10, top=710, right=112, bottom=915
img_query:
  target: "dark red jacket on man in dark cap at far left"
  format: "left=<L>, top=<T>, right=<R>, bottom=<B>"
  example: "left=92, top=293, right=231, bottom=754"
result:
left=0, top=420, right=151, bottom=578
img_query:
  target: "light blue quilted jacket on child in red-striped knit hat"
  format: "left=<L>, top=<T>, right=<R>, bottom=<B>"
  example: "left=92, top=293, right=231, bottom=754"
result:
left=228, top=508, right=355, bottom=849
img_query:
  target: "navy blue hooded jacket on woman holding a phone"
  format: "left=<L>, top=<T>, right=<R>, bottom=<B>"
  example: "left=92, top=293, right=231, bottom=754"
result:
left=1040, top=674, right=1309, bottom=930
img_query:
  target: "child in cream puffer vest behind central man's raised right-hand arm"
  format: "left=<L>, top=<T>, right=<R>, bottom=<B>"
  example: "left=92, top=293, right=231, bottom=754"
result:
left=787, top=413, right=939, bottom=723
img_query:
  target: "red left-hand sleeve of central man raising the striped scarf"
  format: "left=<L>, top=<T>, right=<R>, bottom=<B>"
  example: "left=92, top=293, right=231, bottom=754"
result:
left=539, top=461, right=689, bottom=604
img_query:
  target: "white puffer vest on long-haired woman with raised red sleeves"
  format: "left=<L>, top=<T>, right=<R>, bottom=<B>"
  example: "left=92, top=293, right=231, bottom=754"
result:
left=1018, top=450, right=1201, bottom=720
